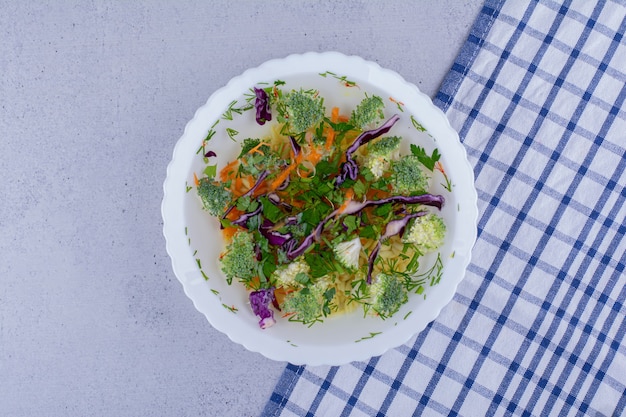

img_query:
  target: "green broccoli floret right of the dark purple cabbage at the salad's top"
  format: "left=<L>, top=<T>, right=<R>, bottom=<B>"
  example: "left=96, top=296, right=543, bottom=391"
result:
left=285, top=90, right=324, bottom=134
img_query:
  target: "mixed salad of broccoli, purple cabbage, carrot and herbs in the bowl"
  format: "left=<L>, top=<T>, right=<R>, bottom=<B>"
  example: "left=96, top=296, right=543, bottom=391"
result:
left=194, top=81, right=446, bottom=328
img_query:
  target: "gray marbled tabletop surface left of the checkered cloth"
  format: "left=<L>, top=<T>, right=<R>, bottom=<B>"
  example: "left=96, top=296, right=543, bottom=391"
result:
left=0, top=0, right=482, bottom=416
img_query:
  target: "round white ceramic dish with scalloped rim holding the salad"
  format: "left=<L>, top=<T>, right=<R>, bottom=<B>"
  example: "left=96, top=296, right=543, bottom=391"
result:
left=161, top=52, right=478, bottom=365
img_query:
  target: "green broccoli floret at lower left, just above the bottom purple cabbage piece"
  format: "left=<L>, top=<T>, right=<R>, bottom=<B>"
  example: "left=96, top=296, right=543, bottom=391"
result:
left=221, top=230, right=257, bottom=283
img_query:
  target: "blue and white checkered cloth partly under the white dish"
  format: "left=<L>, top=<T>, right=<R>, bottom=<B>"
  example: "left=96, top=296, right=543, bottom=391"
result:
left=263, top=0, right=626, bottom=416
